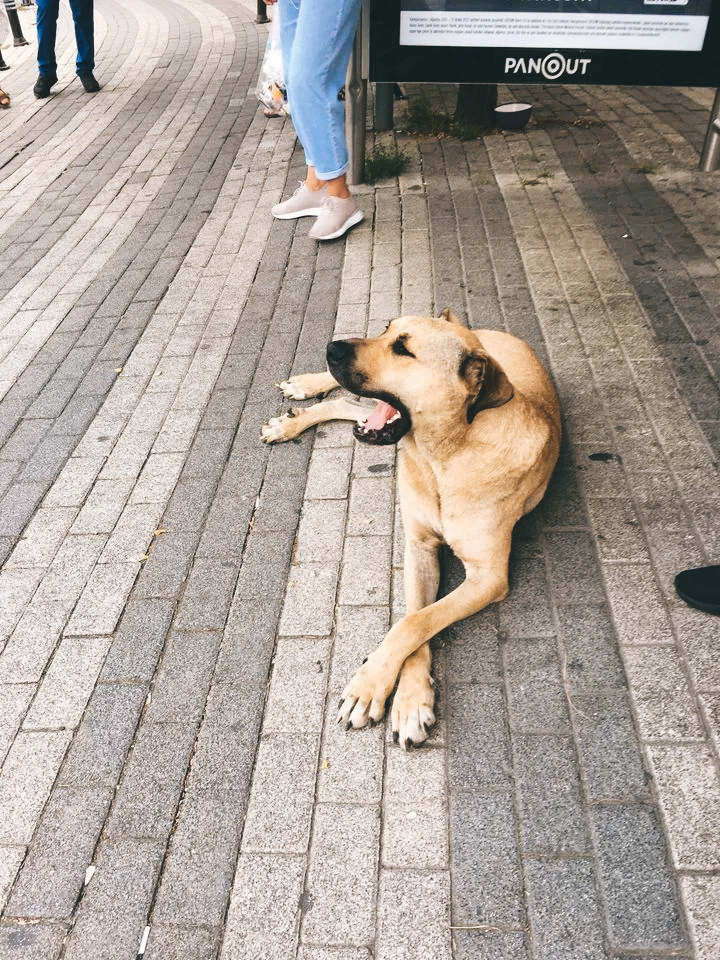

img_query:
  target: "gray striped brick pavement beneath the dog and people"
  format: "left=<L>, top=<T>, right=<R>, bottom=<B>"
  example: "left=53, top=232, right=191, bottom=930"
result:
left=0, top=0, right=720, bottom=960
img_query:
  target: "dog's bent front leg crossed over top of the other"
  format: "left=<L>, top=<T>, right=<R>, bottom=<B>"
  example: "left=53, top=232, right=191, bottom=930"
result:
left=337, top=563, right=508, bottom=727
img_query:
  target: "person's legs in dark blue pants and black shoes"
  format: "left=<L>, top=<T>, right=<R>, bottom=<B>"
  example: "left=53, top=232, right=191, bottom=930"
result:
left=33, top=0, right=100, bottom=99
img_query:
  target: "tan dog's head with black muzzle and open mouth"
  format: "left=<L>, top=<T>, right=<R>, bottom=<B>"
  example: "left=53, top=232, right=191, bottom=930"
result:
left=327, top=310, right=513, bottom=444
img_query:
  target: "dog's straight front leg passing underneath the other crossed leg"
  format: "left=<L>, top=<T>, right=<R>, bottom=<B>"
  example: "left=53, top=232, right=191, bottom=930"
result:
left=392, top=536, right=440, bottom=750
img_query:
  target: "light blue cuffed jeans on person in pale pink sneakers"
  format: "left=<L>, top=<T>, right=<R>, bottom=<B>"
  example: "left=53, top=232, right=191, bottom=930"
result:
left=278, top=0, right=360, bottom=180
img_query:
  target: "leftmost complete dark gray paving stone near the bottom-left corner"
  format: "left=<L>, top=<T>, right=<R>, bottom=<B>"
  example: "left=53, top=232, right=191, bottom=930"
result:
left=8, top=787, right=113, bottom=920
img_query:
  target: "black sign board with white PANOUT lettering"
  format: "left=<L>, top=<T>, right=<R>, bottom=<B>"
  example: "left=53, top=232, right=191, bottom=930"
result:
left=370, top=0, right=720, bottom=87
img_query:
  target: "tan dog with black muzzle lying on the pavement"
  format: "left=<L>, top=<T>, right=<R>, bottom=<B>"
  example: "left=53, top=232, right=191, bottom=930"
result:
left=262, top=310, right=560, bottom=749
